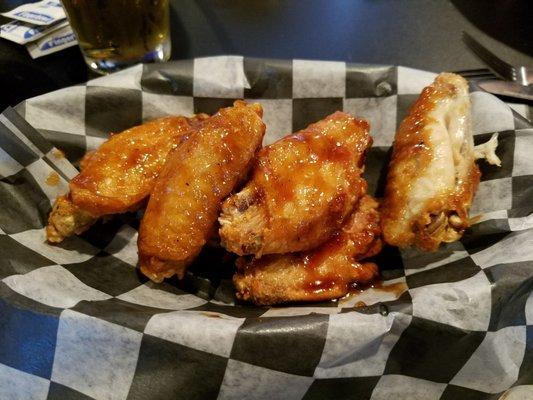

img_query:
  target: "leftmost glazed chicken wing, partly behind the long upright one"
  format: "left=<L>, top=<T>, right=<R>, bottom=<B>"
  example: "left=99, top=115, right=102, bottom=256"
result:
left=46, top=114, right=208, bottom=243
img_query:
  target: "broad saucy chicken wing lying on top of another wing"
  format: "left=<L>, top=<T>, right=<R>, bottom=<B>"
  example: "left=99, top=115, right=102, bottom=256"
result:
left=219, top=112, right=372, bottom=257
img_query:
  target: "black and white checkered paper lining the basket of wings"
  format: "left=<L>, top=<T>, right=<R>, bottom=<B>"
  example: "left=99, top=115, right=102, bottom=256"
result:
left=0, top=56, right=533, bottom=400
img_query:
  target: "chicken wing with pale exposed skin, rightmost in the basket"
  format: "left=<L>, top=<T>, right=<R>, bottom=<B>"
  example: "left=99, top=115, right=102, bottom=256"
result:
left=381, top=73, right=480, bottom=250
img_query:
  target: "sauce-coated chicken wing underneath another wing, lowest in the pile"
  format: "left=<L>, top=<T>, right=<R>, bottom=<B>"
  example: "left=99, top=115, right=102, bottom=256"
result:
left=233, top=196, right=381, bottom=305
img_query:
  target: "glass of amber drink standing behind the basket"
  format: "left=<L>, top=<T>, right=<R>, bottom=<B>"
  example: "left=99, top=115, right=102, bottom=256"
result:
left=61, top=0, right=170, bottom=74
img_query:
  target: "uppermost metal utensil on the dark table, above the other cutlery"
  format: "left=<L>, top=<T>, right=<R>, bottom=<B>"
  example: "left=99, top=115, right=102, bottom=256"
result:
left=463, top=31, right=533, bottom=86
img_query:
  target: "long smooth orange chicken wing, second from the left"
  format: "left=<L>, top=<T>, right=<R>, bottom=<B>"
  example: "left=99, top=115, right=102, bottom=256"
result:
left=138, top=101, right=265, bottom=282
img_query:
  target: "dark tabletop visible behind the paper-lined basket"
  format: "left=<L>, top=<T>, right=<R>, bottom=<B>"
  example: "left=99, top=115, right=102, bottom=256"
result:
left=0, top=0, right=533, bottom=109
